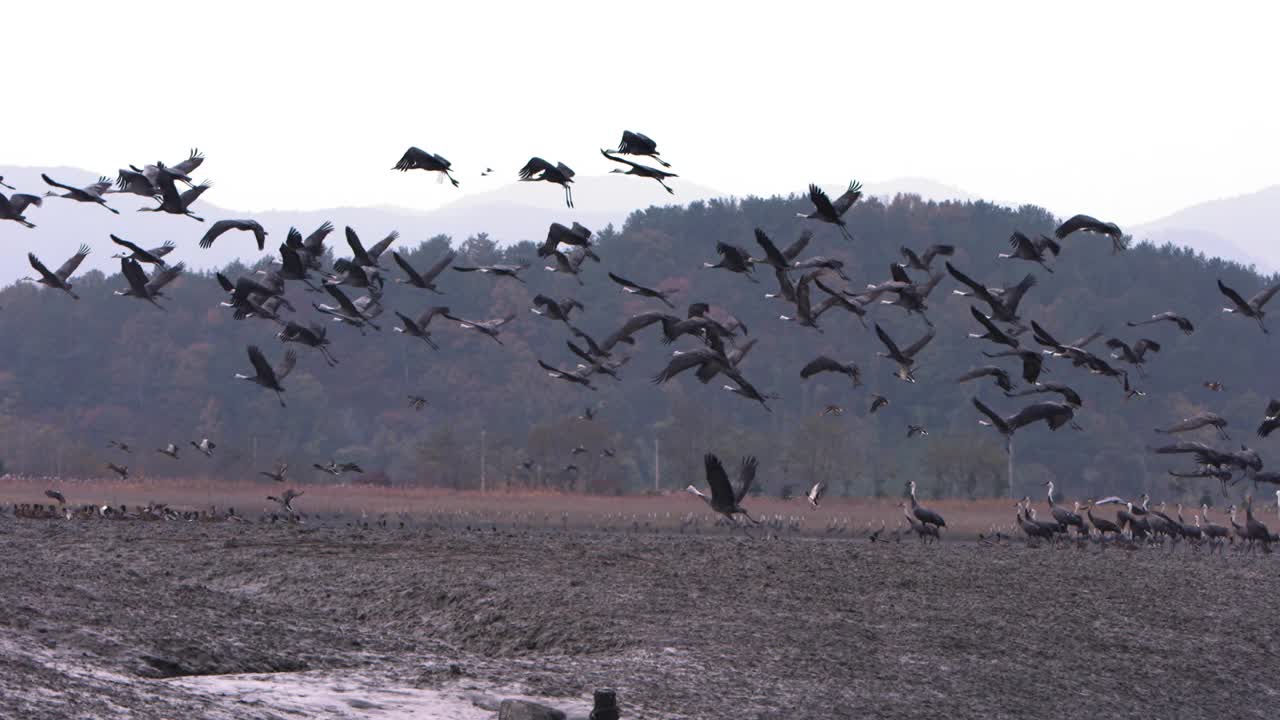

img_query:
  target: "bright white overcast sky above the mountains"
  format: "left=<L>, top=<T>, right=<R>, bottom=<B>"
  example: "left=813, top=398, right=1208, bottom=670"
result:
left=10, top=0, right=1280, bottom=223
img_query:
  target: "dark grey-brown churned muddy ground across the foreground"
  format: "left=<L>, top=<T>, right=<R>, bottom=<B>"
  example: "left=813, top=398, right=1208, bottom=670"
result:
left=0, top=518, right=1280, bottom=720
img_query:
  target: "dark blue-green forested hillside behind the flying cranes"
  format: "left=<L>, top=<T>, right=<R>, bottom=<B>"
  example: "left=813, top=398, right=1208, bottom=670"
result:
left=0, top=196, right=1280, bottom=502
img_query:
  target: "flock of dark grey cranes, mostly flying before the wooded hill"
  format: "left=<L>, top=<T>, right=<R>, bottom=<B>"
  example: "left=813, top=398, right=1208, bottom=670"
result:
left=0, top=131, right=1280, bottom=544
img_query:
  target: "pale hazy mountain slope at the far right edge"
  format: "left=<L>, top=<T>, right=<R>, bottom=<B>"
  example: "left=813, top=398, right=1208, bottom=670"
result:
left=1126, top=184, right=1280, bottom=273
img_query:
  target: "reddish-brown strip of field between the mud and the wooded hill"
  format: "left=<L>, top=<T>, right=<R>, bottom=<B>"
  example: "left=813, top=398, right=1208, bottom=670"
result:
left=0, top=479, right=1039, bottom=539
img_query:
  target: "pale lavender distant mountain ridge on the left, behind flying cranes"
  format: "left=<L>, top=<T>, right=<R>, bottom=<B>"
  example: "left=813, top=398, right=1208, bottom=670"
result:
left=0, top=167, right=721, bottom=284
